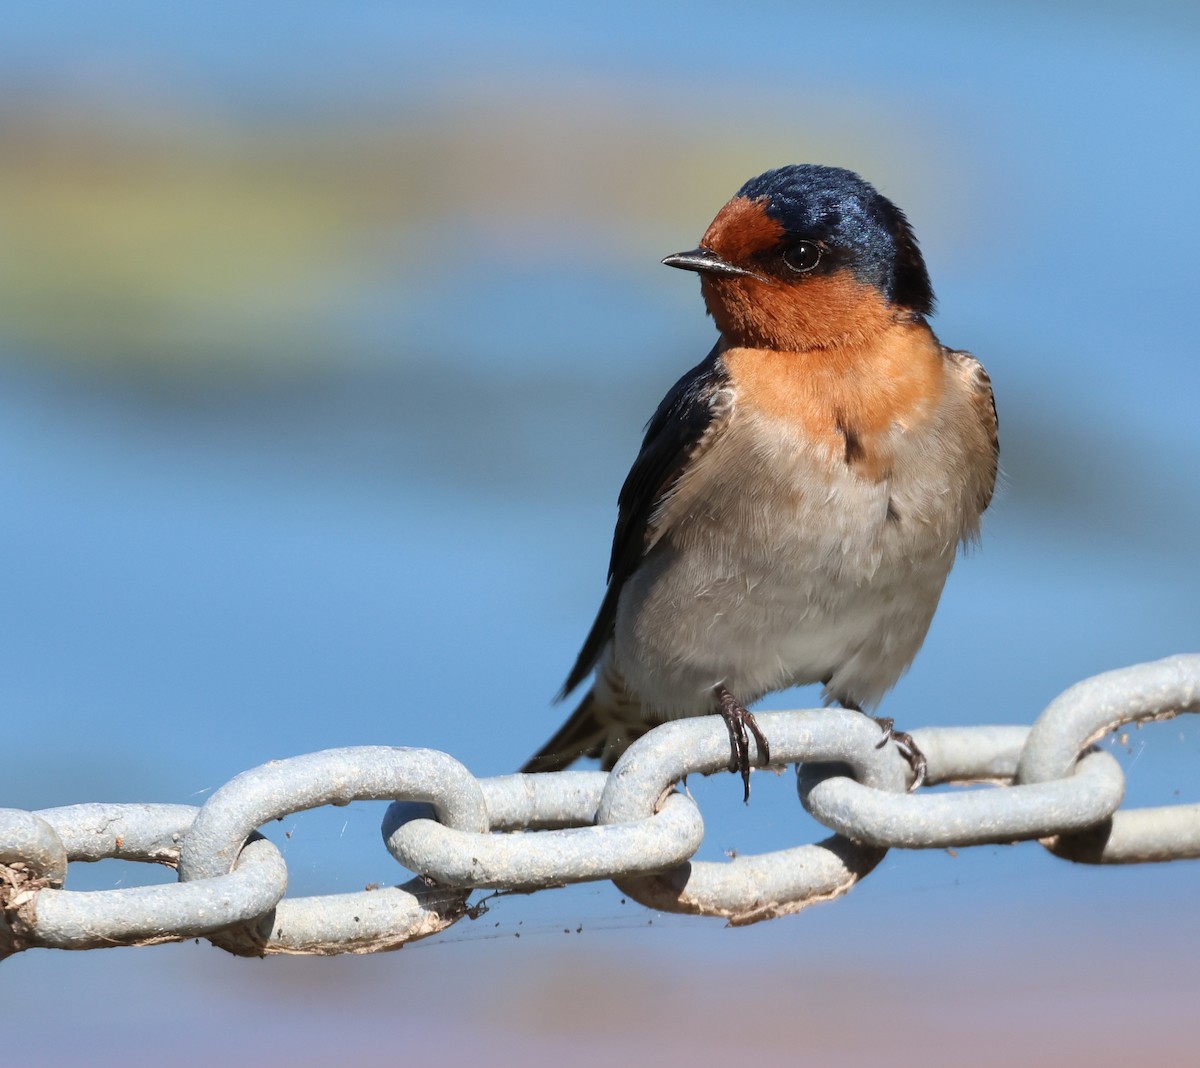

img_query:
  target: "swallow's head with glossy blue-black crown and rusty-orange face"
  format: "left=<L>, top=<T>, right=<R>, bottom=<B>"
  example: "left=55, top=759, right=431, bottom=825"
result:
left=662, top=163, right=934, bottom=350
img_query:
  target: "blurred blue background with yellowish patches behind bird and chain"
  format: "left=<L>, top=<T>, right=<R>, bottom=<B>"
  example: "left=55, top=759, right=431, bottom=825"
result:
left=0, top=0, right=1200, bottom=1066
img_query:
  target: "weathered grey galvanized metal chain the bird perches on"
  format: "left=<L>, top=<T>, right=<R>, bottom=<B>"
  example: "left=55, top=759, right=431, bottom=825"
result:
left=0, top=655, right=1200, bottom=956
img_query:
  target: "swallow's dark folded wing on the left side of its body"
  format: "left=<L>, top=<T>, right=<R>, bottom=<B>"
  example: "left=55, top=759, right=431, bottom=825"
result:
left=559, top=343, right=725, bottom=698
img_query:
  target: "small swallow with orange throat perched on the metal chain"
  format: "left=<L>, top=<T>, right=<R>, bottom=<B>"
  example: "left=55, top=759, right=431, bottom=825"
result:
left=522, top=163, right=1000, bottom=802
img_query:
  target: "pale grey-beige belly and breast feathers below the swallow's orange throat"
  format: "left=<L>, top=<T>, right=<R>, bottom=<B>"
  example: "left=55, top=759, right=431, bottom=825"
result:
left=605, top=394, right=979, bottom=722
